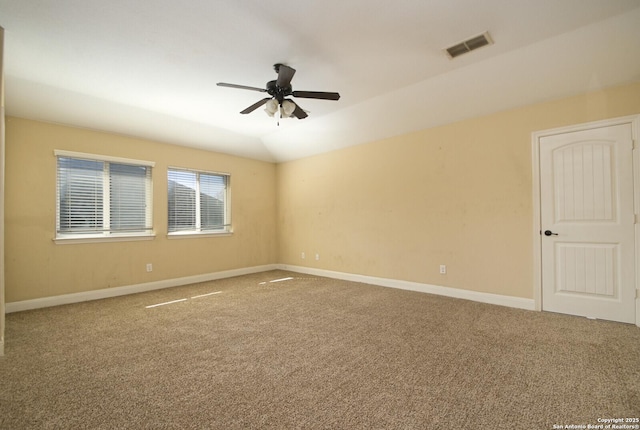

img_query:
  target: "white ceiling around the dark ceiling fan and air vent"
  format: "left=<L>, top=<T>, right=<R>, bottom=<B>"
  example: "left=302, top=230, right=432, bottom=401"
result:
left=0, top=0, right=640, bottom=161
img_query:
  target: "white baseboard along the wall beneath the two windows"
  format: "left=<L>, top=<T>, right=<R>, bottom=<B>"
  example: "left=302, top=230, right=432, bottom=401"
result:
left=5, top=264, right=278, bottom=313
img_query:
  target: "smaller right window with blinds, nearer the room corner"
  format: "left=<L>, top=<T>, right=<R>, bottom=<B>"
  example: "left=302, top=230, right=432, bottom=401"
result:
left=167, top=168, right=231, bottom=234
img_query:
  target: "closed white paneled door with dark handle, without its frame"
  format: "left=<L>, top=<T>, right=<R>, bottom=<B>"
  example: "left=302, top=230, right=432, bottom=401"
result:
left=540, top=124, right=635, bottom=323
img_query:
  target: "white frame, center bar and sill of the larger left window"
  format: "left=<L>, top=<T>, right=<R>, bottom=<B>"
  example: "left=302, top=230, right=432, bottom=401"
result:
left=53, top=149, right=156, bottom=244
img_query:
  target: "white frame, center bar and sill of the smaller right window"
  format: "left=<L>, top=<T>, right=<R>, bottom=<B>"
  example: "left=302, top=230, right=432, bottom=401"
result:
left=167, top=166, right=233, bottom=239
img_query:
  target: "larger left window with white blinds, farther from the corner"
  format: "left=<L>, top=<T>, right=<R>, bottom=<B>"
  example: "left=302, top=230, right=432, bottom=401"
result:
left=55, top=151, right=153, bottom=239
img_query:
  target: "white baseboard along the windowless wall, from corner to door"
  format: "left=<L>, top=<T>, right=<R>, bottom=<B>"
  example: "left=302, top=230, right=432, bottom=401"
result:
left=277, top=264, right=535, bottom=311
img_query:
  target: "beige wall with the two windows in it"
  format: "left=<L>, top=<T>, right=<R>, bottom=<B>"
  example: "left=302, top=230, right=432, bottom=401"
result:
left=6, top=118, right=277, bottom=302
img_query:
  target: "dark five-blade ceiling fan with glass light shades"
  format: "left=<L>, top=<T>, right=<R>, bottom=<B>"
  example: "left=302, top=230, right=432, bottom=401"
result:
left=218, top=63, right=340, bottom=119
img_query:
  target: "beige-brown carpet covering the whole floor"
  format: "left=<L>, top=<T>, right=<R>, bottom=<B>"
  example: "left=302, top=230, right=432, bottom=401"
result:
left=0, top=271, right=640, bottom=430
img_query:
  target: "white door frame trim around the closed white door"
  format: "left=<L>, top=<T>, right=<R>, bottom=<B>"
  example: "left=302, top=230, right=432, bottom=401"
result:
left=531, top=115, right=640, bottom=327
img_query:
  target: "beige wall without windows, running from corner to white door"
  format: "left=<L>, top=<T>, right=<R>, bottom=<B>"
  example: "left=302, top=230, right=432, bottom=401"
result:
left=277, top=83, right=640, bottom=298
